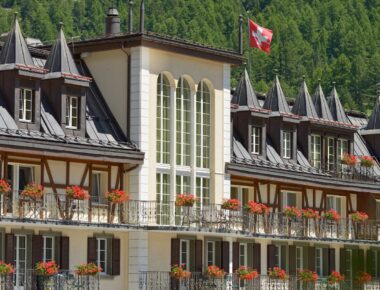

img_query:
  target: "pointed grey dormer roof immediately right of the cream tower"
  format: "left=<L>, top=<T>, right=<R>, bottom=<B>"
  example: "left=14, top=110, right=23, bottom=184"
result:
left=231, top=69, right=260, bottom=110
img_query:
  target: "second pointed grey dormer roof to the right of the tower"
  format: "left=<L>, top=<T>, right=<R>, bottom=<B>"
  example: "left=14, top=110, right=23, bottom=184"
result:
left=263, top=75, right=290, bottom=114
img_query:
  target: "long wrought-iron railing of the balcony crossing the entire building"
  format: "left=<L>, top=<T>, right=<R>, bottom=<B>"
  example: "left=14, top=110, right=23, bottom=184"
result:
left=0, top=193, right=380, bottom=241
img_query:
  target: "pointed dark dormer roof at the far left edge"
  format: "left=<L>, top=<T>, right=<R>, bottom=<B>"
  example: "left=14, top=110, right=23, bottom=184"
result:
left=0, top=17, right=34, bottom=67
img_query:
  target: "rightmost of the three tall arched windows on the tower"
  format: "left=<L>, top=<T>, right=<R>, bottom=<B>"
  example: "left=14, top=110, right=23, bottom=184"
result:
left=195, top=81, right=211, bottom=168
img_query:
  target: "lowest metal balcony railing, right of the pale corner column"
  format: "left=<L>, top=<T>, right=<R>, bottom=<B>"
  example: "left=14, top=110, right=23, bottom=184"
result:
left=139, top=272, right=380, bottom=290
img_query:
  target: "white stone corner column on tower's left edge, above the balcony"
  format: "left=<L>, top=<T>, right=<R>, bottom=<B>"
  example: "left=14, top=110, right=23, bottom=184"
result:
left=130, top=46, right=150, bottom=200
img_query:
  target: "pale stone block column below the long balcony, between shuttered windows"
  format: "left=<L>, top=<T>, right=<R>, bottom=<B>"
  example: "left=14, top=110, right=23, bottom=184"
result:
left=128, top=231, right=149, bottom=289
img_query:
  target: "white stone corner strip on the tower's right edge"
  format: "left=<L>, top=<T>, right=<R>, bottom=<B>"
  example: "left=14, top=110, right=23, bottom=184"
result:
left=223, top=64, right=231, bottom=199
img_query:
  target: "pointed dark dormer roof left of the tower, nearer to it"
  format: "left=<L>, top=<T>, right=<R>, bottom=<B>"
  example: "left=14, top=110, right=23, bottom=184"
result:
left=45, top=27, right=79, bottom=75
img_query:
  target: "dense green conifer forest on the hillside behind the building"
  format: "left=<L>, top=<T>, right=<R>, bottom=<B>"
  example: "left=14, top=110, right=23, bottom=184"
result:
left=0, top=0, right=380, bottom=111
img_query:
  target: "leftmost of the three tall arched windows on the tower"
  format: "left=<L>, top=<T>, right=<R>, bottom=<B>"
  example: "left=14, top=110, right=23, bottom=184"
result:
left=157, top=73, right=170, bottom=164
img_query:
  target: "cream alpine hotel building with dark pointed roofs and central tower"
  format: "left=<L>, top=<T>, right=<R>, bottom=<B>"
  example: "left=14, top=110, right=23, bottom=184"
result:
left=0, top=6, right=380, bottom=289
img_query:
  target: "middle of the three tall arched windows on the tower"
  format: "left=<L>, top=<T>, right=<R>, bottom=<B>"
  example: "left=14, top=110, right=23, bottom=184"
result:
left=176, top=78, right=191, bottom=166
